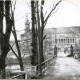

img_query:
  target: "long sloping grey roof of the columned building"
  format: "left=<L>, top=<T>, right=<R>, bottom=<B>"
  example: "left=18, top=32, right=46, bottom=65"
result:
left=44, top=26, right=80, bottom=35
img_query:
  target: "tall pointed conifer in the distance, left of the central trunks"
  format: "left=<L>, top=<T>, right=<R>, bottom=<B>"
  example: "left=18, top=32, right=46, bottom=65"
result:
left=21, top=17, right=32, bottom=56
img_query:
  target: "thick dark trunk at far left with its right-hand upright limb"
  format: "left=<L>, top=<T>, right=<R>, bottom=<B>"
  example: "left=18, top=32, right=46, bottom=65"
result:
left=0, top=1, right=12, bottom=79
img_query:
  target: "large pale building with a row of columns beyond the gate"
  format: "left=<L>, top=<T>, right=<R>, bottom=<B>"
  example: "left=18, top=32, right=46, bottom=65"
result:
left=44, top=26, right=80, bottom=51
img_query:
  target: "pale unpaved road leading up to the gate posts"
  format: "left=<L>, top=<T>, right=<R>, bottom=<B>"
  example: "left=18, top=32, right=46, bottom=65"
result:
left=44, top=52, right=80, bottom=79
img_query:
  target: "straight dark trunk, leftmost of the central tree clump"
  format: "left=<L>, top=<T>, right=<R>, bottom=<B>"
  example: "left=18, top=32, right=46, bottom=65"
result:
left=31, top=1, right=38, bottom=65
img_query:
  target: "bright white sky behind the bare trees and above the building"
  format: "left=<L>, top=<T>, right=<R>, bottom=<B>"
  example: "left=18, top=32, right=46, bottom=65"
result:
left=11, top=0, right=80, bottom=40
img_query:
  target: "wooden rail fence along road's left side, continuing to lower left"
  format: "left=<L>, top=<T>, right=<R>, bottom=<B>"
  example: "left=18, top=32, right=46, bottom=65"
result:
left=9, top=56, right=56, bottom=79
